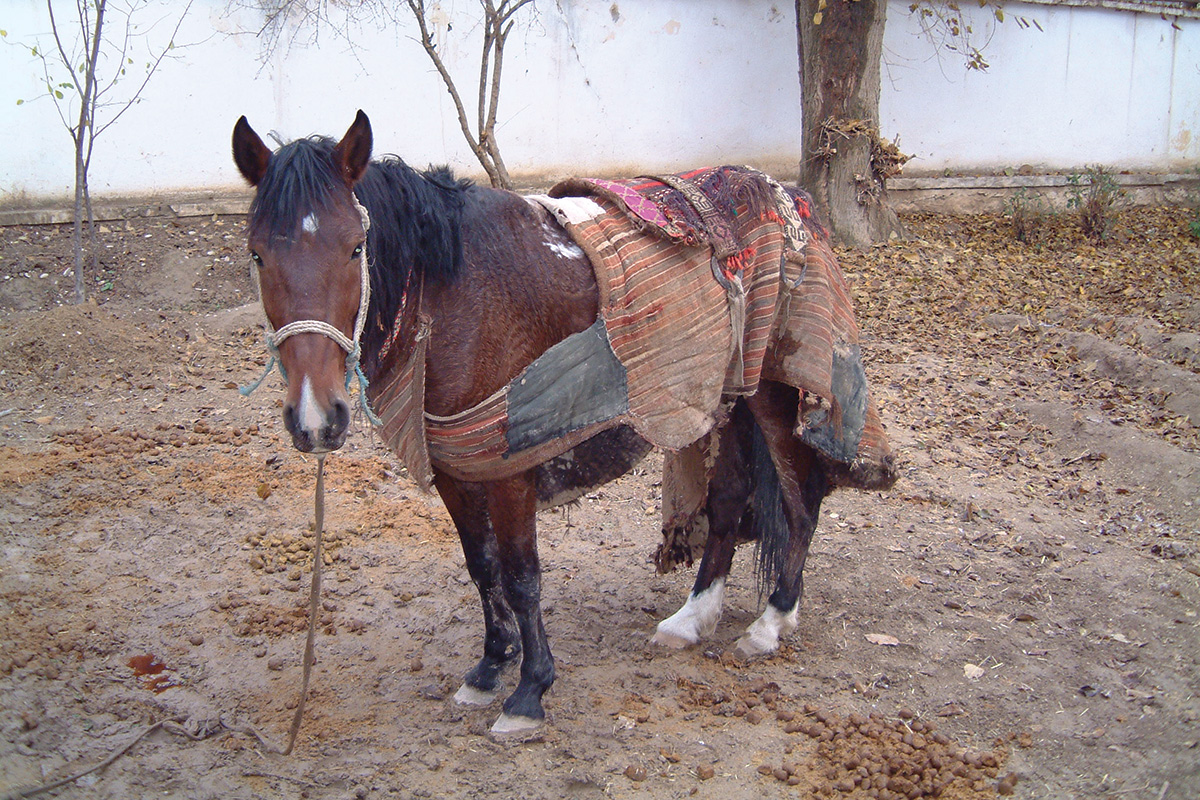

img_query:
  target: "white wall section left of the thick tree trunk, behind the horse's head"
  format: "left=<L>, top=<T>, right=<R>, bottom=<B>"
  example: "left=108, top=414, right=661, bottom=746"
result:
left=0, top=0, right=799, bottom=203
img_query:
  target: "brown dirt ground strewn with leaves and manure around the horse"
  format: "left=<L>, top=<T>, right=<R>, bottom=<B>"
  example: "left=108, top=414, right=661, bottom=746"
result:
left=0, top=209, right=1200, bottom=800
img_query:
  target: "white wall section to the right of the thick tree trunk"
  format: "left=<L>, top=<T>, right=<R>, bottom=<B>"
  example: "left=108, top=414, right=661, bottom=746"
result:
left=880, top=2, right=1200, bottom=174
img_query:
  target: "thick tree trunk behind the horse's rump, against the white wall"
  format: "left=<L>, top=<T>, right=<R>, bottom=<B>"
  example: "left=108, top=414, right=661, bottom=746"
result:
left=796, top=0, right=902, bottom=247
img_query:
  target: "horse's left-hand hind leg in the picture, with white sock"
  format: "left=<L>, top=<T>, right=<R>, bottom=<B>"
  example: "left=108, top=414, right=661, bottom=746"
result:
left=650, top=402, right=754, bottom=648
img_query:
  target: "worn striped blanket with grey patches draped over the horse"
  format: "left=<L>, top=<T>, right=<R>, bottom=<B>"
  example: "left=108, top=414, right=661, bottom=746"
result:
left=372, top=168, right=894, bottom=506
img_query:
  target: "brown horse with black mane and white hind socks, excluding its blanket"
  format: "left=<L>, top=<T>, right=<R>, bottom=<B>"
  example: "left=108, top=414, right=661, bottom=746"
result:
left=233, top=110, right=890, bottom=733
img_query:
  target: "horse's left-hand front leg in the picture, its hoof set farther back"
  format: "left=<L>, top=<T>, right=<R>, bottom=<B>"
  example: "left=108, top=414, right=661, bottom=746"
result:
left=434, top=473, right=521, bottom=705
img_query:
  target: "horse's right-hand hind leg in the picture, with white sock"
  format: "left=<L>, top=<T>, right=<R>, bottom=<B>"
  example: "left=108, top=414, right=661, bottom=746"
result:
left=736, top=381, right=829, bottom=657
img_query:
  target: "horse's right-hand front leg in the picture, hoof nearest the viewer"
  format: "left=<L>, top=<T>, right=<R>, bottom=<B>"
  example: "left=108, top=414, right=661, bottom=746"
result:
left=486, top=473, right=554, bottom=733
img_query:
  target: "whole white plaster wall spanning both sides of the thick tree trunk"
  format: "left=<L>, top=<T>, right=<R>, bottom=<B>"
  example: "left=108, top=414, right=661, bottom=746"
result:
left=0, top=0, right=1200, bottom=205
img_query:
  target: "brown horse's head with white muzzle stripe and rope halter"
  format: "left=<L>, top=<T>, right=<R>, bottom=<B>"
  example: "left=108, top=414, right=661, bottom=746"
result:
left=233, top=112, right=371, bottom=452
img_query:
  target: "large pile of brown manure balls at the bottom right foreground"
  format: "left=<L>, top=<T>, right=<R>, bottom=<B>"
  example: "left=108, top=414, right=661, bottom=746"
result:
left=758, top=705, right=1018, bottom=800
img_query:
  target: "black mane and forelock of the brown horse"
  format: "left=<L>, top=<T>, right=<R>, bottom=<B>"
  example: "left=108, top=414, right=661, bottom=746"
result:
left=250, top=137, right=472, bottom=367
